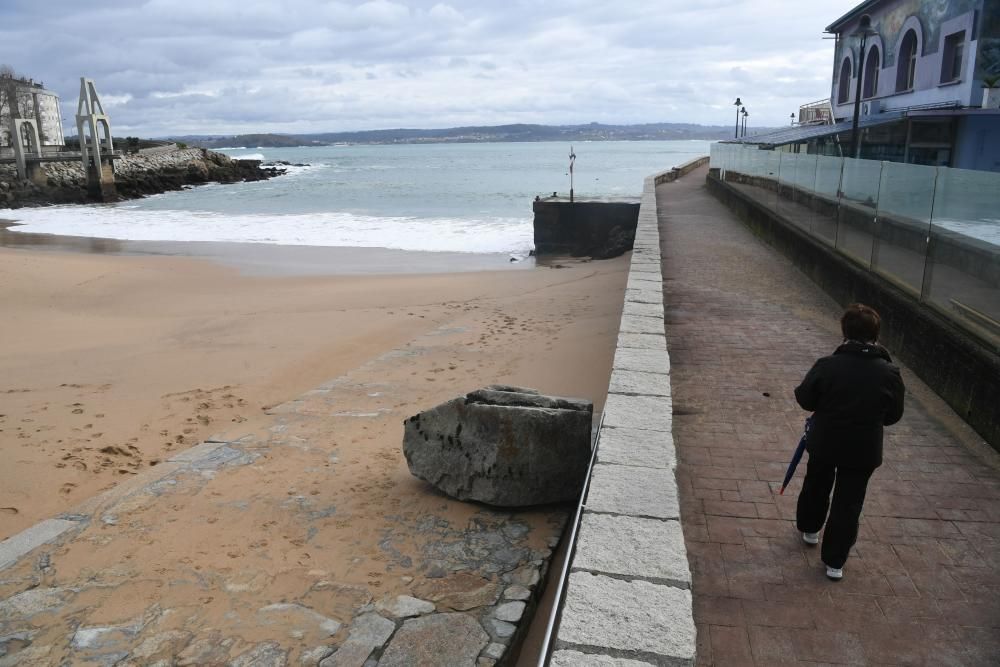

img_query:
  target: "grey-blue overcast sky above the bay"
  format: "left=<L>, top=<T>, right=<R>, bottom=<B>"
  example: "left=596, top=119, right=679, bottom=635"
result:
left=0, top=0, right=858, bottom=136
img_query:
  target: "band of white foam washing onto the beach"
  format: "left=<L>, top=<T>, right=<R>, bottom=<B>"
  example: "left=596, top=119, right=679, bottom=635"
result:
left=0, top=204, right=533, bottom=254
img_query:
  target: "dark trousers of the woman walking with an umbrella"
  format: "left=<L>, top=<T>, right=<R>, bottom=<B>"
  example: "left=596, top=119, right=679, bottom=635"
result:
left=796, top=455, right=875, bottom=568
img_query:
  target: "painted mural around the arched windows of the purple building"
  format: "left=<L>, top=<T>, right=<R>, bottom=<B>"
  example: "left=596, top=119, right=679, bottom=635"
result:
left=834, top=0, right=980, bottom=79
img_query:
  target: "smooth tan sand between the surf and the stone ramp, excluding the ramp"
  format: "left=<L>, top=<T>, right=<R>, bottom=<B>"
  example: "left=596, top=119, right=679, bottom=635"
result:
left=0, top=237, right=626, bottom=538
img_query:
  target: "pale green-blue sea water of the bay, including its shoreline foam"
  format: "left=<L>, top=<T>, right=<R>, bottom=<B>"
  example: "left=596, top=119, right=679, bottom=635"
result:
left=0, top=141, right=710, bottom=255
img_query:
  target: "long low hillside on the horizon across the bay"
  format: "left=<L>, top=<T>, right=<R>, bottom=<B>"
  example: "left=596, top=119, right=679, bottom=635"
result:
left=170, top=123, right=731, bottom=148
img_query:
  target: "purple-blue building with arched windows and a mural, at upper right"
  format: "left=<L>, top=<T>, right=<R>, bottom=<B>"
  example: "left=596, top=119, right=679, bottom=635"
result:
left=824, top=0, right=1000, bottom=171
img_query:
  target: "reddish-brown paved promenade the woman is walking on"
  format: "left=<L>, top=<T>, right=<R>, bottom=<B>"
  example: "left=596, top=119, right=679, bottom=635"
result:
left=657, top=168, right=1000, bottom=666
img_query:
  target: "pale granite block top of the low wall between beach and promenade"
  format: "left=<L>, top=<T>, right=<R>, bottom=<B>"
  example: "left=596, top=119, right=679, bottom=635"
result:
left=550, top=175, right=707, bottom=667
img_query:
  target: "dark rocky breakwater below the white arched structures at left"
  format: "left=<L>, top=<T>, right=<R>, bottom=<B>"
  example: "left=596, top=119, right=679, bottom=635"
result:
left=0, top=148, right=285, bottom=208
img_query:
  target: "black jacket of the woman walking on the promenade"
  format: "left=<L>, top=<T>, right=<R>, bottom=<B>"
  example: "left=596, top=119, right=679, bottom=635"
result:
left=795, top=341, right=905, bottom=470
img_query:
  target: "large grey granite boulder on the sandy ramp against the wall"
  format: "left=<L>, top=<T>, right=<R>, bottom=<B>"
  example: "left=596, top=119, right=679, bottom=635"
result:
left=403, top=385, right=594, bottom=507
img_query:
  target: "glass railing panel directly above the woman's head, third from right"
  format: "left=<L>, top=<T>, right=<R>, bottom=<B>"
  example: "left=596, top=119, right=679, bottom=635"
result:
left=836, top=160, right=882, bottom=267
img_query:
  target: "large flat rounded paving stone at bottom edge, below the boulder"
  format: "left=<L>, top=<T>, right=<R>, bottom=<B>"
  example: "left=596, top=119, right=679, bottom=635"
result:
left=378, top=613, right=490, bottom=667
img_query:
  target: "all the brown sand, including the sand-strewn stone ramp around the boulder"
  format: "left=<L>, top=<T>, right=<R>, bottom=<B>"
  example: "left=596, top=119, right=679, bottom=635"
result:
left=0, top=235, right=628, bottom=664
